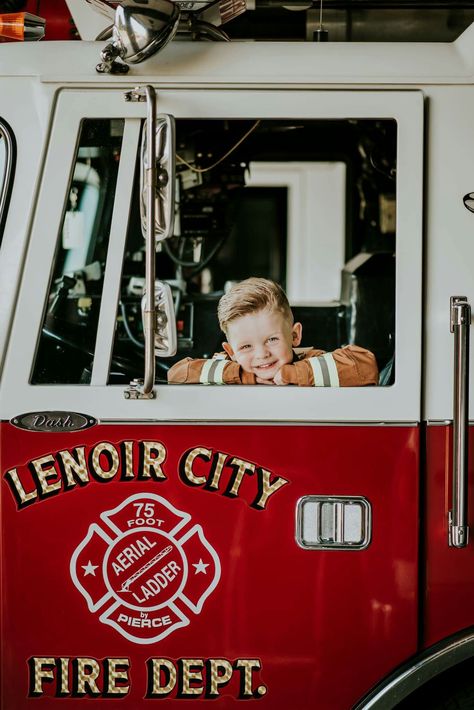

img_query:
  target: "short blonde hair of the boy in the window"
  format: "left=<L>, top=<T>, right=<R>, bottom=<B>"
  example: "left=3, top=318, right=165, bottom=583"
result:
left=217, top=277, right=293, bottom=335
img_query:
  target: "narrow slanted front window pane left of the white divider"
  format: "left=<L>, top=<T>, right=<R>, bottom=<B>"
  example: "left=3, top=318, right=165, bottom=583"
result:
left=32, top=119, right=124, bottom=384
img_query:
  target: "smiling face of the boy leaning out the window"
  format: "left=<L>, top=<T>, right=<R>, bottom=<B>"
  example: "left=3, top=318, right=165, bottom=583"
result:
left=222, top=309, right=302, bottom=380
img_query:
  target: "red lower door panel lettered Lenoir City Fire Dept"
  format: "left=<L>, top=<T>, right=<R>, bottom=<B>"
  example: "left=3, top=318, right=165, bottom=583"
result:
left=1, top=423, right=419, bottom=710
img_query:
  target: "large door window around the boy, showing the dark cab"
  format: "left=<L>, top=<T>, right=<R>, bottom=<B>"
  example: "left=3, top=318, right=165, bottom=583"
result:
left=109, top=119, right=397, bottom=384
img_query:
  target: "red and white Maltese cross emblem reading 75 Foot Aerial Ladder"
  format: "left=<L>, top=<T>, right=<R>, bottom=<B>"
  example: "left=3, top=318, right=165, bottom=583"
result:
left=70, top=493, right=221, bottom=644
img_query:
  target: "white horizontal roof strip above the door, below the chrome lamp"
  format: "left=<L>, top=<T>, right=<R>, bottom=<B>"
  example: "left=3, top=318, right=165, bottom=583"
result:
left=2, top=35, right=474, bottom=88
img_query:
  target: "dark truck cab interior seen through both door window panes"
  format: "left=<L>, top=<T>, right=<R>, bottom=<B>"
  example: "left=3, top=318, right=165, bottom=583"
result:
left=31, top=117, right=397, bottom=385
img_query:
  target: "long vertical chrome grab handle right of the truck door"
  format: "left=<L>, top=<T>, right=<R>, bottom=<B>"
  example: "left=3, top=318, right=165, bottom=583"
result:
left=449, top=296, right=471, bottom=547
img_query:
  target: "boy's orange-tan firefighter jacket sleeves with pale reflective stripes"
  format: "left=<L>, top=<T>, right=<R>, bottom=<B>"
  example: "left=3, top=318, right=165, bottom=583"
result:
left=168, top=345, right=378, bottom=387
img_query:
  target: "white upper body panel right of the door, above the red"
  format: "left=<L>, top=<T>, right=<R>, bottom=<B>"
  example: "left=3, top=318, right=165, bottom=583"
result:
left=424, top=87, right=474, bottom=420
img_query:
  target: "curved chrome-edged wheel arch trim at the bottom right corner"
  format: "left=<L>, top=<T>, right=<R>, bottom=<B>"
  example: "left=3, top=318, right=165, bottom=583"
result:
left=352, top=628, right=474, bottom=710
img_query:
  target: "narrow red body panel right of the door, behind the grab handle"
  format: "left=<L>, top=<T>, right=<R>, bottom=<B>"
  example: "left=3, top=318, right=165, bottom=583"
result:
left=424, top=426, right=474, bottom=646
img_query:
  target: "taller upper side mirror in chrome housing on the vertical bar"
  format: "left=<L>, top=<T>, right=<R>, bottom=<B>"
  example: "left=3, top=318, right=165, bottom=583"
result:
left=140, top=114, right=176, bottom=242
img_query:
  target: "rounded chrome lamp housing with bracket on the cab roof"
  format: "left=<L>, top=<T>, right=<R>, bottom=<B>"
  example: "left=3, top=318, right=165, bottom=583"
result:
left=96, top=0, right=180, bottom=74
